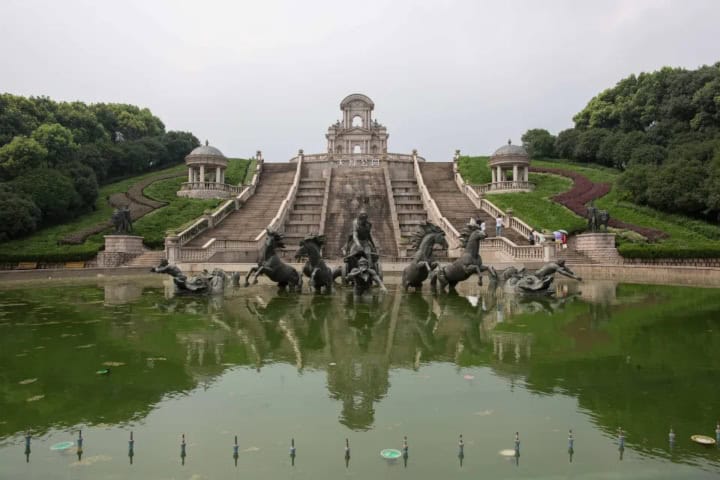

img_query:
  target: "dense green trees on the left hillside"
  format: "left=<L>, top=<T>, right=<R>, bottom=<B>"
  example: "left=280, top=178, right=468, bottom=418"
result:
left=0, top=93, right=199, bottom=241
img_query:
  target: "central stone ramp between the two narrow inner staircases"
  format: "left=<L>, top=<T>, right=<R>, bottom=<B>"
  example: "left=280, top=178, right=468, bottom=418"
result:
left=317, top=168, right=398, bottom=259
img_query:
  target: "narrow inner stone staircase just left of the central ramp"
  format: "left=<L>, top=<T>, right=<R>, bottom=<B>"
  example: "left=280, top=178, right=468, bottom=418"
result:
left=283, top=177, right=327, bottom=260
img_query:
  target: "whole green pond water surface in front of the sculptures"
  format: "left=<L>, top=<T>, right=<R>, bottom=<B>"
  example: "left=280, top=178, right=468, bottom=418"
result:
left=0, top=276, right=720, bottom=480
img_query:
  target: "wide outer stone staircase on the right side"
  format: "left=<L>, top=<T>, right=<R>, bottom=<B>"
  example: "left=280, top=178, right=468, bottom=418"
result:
left=420, top=162, right=529, bottom=245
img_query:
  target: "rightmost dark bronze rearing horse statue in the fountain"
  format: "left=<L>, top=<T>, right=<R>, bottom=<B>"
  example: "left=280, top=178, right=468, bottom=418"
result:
left=430, top=223, right=492, bottom=292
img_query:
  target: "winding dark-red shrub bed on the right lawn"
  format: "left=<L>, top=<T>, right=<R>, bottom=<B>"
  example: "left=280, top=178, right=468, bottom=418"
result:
left=530, top=167, right=668, bottom=242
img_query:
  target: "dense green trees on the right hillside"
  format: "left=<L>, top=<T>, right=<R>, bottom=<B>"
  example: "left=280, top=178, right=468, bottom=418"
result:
left=523, top=63, right=720, bottom=219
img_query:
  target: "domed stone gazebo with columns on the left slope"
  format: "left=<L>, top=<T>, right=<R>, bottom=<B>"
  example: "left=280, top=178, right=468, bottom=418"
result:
left=177, top=140, right=248, bottom=198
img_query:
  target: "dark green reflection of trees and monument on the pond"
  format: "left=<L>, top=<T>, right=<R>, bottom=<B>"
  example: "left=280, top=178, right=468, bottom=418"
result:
left=0, top=282, right=720, bottom=472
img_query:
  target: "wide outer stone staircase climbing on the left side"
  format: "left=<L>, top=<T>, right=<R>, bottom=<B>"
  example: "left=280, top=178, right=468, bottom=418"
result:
left=186, top=163, right=297, bottom=247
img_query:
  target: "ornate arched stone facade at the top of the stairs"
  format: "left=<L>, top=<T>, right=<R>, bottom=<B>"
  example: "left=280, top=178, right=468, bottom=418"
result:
left=325, top=93, right=389, bottom=155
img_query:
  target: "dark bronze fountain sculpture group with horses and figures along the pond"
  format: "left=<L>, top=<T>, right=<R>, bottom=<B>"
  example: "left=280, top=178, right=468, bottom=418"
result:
left=152, top=212, right=582, bottom=295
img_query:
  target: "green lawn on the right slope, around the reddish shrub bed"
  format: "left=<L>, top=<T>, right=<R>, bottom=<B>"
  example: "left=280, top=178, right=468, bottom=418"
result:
left=459, top=157, right=720, bottom=248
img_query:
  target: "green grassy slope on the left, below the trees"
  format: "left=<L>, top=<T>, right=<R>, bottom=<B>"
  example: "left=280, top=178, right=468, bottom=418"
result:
left=0, top=158, right=254, bottom=263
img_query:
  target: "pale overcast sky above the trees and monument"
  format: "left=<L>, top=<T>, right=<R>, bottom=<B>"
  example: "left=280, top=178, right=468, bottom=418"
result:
left=0, top=0, right=720, bottom=161
